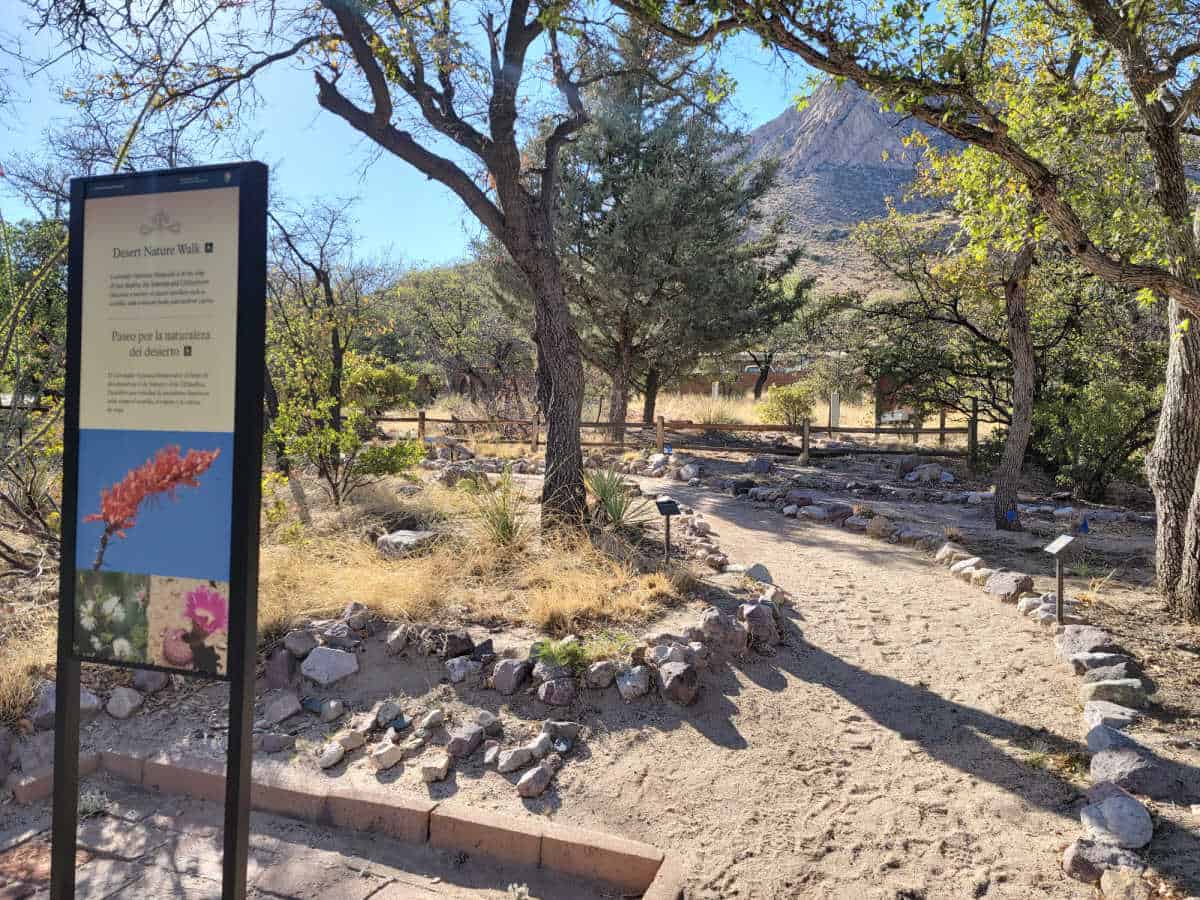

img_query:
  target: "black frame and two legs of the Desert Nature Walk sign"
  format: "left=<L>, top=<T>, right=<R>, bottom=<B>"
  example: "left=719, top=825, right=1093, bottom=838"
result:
left=50, top=162, right=268, bottom=900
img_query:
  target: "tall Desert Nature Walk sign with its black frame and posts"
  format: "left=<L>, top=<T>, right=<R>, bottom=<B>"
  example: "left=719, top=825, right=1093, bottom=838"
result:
left=50, top=162, right=266, bottom=900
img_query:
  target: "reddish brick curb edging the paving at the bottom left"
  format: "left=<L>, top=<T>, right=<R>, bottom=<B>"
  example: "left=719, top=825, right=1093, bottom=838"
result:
left=12, top=751, right=684, bottom=900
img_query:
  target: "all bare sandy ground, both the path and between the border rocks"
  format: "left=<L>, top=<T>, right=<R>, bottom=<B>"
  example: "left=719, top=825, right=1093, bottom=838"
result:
left=11, top=460, right=1200, bottom=900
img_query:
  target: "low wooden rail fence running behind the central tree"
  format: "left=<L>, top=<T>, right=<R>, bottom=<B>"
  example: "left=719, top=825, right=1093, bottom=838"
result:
left=376, top=412, right=979, bottom=466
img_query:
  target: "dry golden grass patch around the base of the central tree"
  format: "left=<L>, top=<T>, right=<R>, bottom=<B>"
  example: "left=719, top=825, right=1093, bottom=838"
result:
left=259, top=485, right=691, bottom=638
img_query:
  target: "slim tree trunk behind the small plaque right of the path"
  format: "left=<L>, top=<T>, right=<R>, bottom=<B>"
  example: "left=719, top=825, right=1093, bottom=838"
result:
left=994, top=244, right=1037, bottom=532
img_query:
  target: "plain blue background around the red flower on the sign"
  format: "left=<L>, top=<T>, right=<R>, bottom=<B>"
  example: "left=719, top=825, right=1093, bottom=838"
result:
left=76, top=428, right=233, bottom=581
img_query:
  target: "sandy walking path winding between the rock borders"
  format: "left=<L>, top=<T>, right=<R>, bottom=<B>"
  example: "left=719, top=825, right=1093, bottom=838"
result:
left=580, top=481, right=1091, bottom=900
